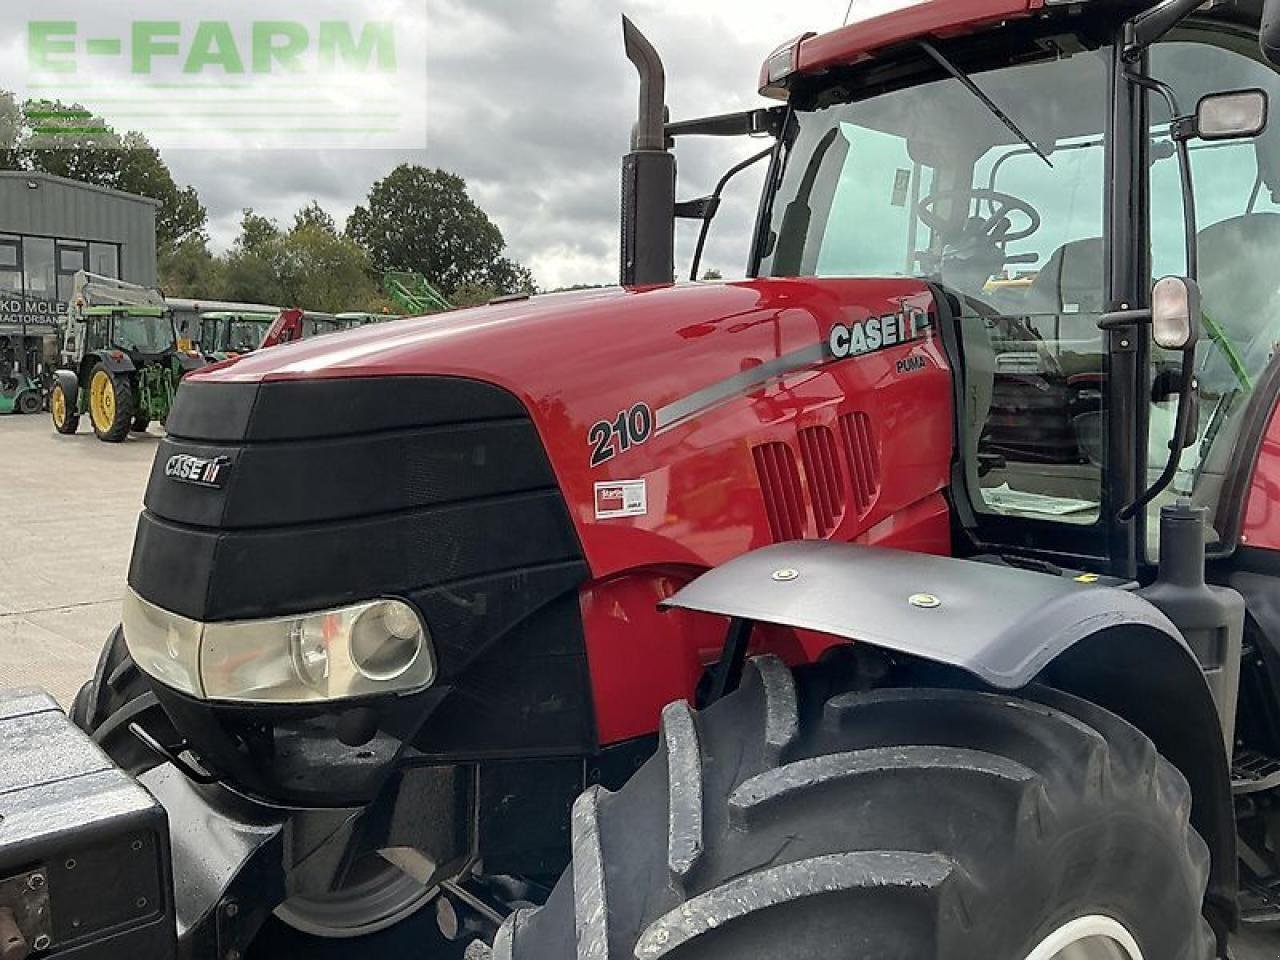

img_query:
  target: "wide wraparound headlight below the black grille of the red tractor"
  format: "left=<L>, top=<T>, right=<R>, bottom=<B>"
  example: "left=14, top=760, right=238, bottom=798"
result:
left=124, top=590, right=435, bottom=703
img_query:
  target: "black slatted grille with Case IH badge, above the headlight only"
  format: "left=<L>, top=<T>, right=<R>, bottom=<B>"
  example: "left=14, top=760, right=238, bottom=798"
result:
left=129, top=378, right=581, bottom=621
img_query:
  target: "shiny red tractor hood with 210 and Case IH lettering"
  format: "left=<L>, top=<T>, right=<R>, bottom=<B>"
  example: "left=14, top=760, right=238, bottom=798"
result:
left=179, top=279, right=951, bottom=573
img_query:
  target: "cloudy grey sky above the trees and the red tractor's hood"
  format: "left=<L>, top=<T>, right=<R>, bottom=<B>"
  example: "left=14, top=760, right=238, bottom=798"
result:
left=10, top=0, right=860, bottom=288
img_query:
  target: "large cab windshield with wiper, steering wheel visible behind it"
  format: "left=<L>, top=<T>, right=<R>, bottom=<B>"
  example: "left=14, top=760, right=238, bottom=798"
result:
left=762, top=41, right=1111, bottom=525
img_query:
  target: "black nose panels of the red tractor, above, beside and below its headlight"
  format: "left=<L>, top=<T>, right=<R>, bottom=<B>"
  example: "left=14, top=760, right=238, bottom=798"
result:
left=129, top=376, right=595, bottom=804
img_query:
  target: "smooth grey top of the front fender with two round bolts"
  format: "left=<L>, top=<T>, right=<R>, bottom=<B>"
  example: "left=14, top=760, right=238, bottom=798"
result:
left=664, top=540, right=1182, bottom=692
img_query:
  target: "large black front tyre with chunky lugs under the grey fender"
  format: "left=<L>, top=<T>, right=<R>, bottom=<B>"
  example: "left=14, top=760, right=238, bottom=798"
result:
left=493, top=658, right=1215, bottom=960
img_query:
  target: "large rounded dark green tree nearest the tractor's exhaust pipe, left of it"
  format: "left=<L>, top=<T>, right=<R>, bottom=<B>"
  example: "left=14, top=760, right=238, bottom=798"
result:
left=347, top=164, right=532, bottom=300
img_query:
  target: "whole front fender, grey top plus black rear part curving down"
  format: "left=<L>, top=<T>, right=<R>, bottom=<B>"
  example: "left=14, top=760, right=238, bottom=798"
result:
left=663, top=540, right=1236, bottom=932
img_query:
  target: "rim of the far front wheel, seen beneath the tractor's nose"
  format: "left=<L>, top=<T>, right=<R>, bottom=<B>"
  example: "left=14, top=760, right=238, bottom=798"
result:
left=275, top=854, right=436, bottom=940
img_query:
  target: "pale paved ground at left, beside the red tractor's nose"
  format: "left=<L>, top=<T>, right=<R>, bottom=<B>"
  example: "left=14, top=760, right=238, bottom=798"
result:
left=0, top=415, right=1280, bottom=960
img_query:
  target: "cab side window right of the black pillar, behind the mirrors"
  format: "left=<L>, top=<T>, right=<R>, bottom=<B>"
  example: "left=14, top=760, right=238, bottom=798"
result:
left=1147, top=29, right=1280, bottom=559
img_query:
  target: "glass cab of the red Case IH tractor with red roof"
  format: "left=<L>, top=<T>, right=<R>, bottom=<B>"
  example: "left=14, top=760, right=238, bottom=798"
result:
left=634, top=1, right=1280, bottom=576
